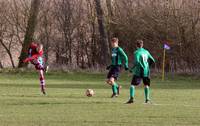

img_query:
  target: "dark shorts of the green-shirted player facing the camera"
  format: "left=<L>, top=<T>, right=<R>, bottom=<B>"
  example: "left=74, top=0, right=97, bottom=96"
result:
left=107, top=66, right=121, bottom=80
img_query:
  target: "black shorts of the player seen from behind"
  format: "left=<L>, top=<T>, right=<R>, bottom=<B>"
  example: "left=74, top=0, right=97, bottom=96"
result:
left=131, top=75, right=150, bottom=86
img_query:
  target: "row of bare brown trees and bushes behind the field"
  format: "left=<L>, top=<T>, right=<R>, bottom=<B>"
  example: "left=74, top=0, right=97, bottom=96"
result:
left=0, top=0, right=200, bottom=72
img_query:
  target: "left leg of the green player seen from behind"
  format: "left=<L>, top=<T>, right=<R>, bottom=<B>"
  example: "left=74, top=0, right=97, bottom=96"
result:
left=126, top=76, right=141, bottom=104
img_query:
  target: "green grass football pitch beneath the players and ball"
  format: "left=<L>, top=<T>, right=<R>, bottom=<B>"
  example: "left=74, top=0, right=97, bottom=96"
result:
left=0, top=73, right=200, bottom=126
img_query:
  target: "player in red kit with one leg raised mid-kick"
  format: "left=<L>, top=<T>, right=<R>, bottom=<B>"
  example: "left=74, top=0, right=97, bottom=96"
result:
left=24, top=42, right=48, bottom=95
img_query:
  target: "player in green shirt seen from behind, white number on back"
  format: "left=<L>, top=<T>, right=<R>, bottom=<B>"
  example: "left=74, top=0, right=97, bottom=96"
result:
left=127, top=40, right=155, bottom=104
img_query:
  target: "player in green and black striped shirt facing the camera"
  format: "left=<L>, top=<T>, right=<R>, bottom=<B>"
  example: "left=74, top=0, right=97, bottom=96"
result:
left=107, top=38, right=128, bottom=98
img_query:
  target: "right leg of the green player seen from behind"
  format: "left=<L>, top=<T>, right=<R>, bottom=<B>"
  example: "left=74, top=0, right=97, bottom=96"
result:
left=143, top=77, right=150, bottom=103
